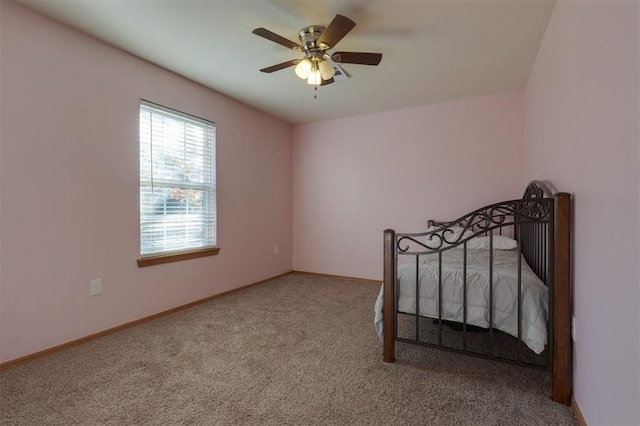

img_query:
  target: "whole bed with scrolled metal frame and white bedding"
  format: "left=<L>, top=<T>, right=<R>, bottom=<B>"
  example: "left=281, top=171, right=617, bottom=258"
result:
left=374, top=181, right=572, bottom=405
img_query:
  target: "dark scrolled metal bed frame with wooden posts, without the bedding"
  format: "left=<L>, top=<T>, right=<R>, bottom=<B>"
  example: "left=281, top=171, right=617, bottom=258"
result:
left=383, top=181, right=573, bottom=405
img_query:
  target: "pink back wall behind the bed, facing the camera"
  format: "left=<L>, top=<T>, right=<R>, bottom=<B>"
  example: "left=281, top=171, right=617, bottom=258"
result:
left=292, top=91, right=525, bottom=279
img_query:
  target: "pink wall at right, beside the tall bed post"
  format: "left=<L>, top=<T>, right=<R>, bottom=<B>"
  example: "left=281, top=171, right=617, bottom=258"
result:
left=524, top=1, right=640, bottom=425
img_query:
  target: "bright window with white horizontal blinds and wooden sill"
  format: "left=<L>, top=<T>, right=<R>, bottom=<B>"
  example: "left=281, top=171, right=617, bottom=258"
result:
left=138, top=101, right=218, bottom=266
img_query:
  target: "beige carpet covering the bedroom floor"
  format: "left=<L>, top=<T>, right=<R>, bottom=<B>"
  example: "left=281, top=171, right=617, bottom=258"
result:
left=0, top=274, right=576, bottom=425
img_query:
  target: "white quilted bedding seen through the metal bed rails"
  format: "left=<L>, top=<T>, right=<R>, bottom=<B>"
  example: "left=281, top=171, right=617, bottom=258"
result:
left=374, top=249, right=549, bottom=354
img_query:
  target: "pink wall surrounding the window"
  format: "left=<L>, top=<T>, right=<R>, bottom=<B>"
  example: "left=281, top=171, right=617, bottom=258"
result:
left=0, top=1, right=292, bottom=361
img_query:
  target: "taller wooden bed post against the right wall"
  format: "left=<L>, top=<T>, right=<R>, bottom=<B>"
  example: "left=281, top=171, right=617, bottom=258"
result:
left=552, top=192, right=573, bottom=405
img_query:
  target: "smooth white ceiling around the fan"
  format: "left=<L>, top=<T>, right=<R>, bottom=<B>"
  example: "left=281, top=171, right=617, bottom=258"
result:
left=14, top=0, right=554, bottom=123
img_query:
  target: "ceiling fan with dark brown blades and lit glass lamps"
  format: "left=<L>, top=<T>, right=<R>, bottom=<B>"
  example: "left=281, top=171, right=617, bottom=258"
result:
left=253, top=15, right=382, bottom=87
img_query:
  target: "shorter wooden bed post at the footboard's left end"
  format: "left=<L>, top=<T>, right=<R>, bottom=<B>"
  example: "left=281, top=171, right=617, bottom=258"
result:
left=382, top=229, right=396, bottom=362
